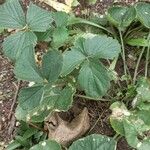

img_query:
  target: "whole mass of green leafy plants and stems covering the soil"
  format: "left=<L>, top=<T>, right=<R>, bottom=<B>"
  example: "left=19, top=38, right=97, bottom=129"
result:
left=0, top=0, right=150, bottom=150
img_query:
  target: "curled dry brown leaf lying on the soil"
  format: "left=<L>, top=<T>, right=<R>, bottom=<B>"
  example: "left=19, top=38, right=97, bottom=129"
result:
left=45, top=108, right=90, bottom=146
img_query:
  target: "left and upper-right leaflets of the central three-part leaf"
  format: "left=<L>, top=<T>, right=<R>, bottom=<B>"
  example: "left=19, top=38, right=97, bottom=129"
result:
left=62, top=35, right=120, bottom=76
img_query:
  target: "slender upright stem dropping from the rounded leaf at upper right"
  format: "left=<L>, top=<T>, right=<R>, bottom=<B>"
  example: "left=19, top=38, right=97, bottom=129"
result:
left=119, top=29, right=127, bottom=82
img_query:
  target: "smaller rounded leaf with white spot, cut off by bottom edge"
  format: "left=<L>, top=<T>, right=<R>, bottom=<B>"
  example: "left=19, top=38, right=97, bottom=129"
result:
left=29, top=140, right=62, bottom=150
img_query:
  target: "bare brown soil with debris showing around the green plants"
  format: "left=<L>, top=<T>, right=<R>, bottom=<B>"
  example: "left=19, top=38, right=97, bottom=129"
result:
left=0, top=0, right=148, bottom=150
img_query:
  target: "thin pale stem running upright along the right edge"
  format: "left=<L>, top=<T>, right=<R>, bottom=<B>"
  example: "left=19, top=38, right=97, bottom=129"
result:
left=145, top=31, right=150, bottom=77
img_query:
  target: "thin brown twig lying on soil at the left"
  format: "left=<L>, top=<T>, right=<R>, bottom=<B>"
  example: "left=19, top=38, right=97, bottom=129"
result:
left=8, top=80, right=21, bottom=120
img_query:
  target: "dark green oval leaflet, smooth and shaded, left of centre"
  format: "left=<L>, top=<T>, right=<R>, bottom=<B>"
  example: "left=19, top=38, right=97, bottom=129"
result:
left=42, top=51, right=63, bottom=82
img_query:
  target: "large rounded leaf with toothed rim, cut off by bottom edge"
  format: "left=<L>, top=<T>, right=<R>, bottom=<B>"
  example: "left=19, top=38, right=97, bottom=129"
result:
left=69, top=134, right=116, bottom=150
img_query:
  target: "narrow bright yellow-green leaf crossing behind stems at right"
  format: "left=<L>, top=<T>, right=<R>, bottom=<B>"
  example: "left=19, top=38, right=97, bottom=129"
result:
left=126, top=38, right=149, bottom=47
